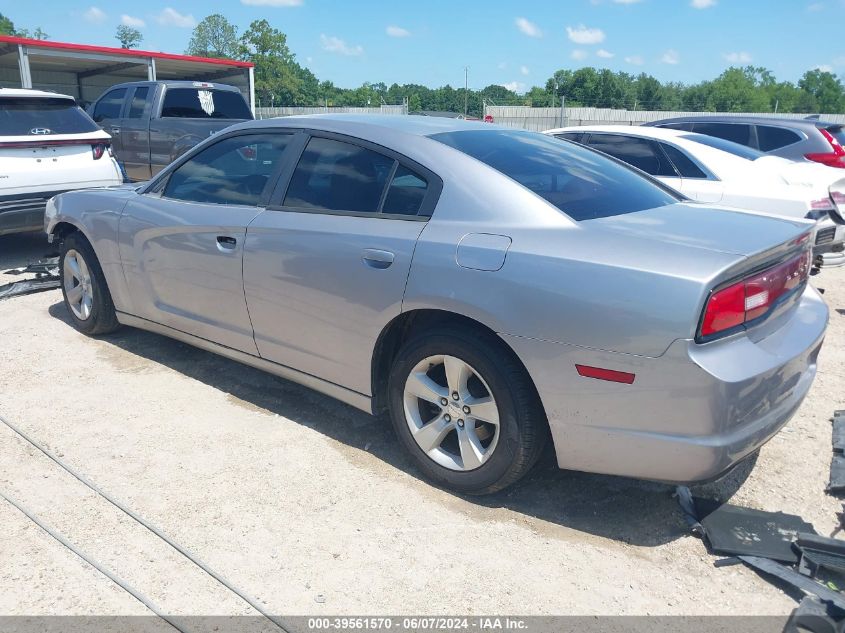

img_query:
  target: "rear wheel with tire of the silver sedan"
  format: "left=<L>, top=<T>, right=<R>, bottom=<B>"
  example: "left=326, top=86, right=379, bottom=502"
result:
left=388, top=328, right=548, bottom=494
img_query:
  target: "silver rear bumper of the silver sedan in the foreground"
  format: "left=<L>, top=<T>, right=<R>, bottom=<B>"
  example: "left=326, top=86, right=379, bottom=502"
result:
left=504, top=287, right=828, bottom=483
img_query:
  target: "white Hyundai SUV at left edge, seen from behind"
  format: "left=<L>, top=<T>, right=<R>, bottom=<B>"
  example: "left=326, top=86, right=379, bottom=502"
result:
left=0, top=88, right=123, bottom=235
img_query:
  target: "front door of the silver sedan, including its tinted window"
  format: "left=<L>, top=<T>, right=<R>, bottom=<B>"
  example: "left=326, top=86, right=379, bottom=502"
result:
left=119, top=131, right=292, bottom=354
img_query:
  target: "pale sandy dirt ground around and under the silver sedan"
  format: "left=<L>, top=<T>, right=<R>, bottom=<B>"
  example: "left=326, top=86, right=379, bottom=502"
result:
left=0, top=228, right=845, bottom=615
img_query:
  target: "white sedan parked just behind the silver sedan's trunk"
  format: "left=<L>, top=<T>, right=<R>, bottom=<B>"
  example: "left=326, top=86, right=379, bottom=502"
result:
left=545, top=125, right=845, bottom=265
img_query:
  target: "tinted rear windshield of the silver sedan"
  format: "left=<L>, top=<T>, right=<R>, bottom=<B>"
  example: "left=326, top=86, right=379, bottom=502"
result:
left=431, top=130, right=680, bottom=221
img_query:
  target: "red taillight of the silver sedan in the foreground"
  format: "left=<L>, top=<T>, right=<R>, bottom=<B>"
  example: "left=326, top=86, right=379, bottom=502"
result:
left=699, top=250, right=812, bottom=338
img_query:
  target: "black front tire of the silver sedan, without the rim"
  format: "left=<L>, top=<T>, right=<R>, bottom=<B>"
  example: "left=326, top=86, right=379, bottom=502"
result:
left=59, top=232, right=120, bottom=336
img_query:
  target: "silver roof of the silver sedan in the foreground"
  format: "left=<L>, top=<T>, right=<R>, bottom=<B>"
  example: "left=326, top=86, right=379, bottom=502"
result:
left=233, top=114, right=504, bottom=136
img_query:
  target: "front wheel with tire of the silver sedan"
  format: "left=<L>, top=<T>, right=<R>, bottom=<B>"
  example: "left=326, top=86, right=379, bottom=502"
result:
left=59, top=233, right=120, bottom=334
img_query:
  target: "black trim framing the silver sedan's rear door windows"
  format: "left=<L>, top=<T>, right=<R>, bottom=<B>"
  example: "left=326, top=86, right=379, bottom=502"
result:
left=266, top=128, right=443, bottom=222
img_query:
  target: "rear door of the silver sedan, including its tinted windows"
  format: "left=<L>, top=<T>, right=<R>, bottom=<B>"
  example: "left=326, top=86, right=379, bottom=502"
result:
left=244, top=133, right=440, bottom=395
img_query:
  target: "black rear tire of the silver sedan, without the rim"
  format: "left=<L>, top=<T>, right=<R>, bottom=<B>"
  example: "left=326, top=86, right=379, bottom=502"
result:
left=388, top=327, right=549, bottom=495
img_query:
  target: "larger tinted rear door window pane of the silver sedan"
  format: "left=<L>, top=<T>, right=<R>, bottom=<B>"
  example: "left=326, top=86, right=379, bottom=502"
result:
left=284, top=137, right=396, bottom=213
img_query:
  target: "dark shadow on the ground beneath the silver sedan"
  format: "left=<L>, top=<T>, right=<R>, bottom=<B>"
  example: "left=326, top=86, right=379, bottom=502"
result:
left=44, top=303, right=753, bottom=546
